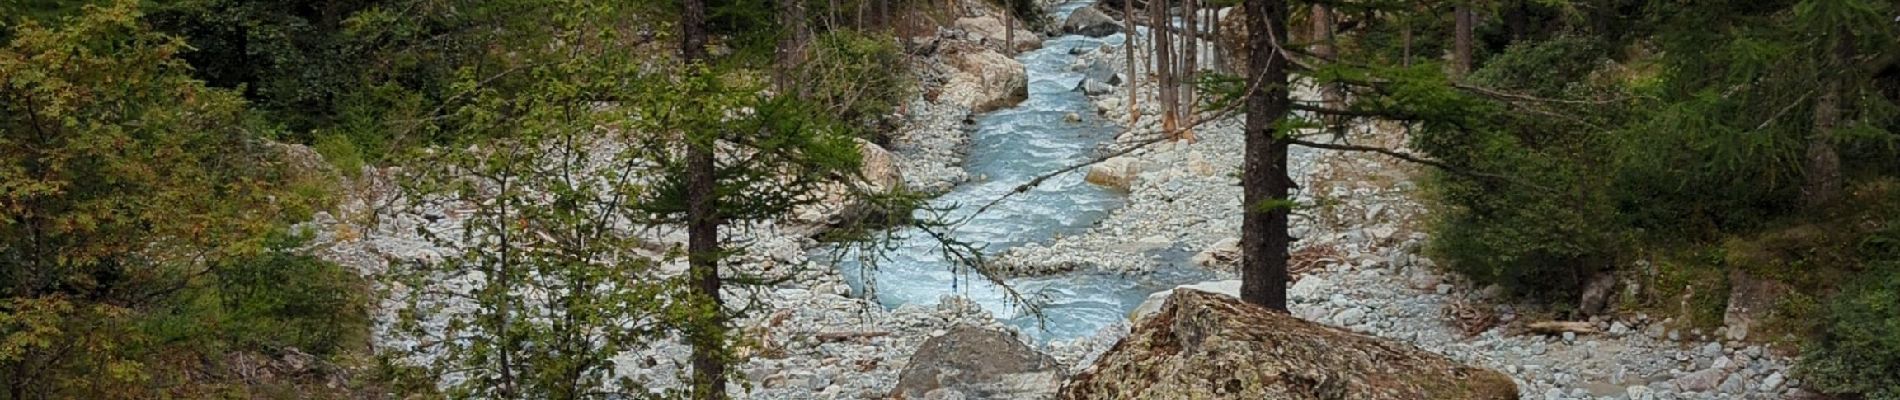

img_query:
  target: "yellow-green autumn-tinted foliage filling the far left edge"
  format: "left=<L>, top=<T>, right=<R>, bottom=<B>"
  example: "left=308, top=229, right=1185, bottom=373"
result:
left=0, top=2, right=367, bottom=398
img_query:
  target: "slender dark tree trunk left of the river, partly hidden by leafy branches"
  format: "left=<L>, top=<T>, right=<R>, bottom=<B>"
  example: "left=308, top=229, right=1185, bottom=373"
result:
left=680, top=0, right=726, bottom=400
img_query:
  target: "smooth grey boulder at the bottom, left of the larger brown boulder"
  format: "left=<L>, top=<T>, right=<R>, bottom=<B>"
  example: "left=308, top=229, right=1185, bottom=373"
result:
left=891, top=326, right=1066, bottom=400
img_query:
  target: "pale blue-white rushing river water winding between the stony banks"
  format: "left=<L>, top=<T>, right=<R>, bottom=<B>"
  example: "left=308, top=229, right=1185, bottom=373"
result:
left=838, top=2, right=1207, bottom=341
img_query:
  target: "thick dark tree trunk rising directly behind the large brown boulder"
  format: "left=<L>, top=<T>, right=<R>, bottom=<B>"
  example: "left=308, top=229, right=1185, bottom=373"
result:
left=1241, top=0, right=1292, bottom=311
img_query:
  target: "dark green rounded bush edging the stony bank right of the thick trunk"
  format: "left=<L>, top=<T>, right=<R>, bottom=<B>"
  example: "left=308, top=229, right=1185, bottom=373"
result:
left=1412, top=38, right=1628, bottom=301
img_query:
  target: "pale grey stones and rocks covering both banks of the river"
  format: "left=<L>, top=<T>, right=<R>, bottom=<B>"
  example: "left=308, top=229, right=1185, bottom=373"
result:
left=315, top=6, right=1803, bottom=398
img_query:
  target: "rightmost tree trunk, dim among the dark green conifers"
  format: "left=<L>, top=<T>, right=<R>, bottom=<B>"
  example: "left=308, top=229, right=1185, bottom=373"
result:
left=1801, top=30, right=1854, bottom=209
